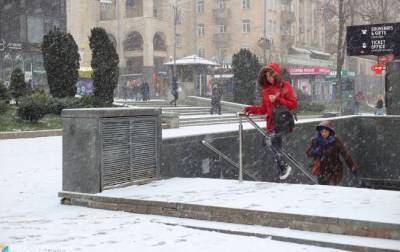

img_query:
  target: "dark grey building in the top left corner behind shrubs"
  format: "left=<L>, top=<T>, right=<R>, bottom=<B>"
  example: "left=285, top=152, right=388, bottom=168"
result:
left=0, top=0, right=66, bottom=87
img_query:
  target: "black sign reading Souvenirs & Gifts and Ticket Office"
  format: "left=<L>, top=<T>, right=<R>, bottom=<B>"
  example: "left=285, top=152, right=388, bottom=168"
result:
left=346, top=23, right=400, bottom=56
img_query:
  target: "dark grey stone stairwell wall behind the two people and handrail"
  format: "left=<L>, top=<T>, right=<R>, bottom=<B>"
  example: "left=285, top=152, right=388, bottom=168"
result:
left=161, top=116, right=400, bottom=185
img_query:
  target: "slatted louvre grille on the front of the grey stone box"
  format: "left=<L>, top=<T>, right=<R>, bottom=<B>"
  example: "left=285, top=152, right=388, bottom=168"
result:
left=100, top=117, right=159, bottom=190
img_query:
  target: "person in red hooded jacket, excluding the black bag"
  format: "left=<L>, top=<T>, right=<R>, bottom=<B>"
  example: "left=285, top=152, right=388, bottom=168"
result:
left=243, top=63, right=297, bottom=179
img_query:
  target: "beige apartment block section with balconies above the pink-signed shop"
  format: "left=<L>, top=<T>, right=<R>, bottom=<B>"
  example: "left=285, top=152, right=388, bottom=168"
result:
left=178, top=0, right=333, bottom=95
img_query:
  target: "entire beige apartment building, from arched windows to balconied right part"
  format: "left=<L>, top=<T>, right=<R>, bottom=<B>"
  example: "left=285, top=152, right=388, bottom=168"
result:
left=67, top=0, right=330, bottom=97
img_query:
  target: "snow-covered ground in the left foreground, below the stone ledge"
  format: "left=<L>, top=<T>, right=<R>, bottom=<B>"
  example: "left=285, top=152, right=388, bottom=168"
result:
left=0, top=137, right=346, bottom=252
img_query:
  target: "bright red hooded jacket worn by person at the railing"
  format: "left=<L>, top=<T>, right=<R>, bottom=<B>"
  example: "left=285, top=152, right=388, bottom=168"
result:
left=245, top=63, right=297, bottom=132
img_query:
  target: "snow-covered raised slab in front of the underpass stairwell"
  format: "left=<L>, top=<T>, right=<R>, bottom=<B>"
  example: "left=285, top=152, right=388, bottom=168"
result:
left=100, top=178, right=400, bottom=224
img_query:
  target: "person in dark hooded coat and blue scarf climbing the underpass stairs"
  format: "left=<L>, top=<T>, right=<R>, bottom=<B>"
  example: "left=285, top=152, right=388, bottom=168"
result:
left=306, top=121, right=358, bottom=185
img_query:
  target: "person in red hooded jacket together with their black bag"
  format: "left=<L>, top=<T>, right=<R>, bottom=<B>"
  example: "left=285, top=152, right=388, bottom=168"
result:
left=243, top=63, right=297, bottom=179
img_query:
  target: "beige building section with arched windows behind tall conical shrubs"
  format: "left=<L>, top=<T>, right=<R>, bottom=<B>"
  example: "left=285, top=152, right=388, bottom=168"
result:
left=67, top=0, right=183, bottom=97
